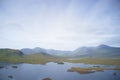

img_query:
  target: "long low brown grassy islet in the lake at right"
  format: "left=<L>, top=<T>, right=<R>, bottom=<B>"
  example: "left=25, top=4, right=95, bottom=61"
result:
left=67, top=67, right=120, bottom=74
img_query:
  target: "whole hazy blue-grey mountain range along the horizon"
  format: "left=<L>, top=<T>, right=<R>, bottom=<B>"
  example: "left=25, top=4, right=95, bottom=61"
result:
left=21, top=44, right=120, bottom=57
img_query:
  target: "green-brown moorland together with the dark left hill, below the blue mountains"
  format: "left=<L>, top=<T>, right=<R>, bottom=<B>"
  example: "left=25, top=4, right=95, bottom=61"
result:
left=0, top=49, right=120, bottom=66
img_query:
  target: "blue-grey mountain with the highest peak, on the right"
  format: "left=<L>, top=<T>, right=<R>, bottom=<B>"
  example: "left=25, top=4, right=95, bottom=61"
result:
left=72, top=44, right=120, bottom=57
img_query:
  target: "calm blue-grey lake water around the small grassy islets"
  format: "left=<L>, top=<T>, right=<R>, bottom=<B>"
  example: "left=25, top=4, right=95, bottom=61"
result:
left=0, top=62, right=120, bottom=80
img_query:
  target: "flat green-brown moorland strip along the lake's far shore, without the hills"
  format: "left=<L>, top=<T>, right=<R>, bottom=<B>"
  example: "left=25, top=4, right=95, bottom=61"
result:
left=0, top=54, right=120, bottom=66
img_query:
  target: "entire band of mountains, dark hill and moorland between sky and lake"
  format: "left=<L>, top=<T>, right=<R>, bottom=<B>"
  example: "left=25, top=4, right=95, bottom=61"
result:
left=0, top=45, right=120, bottom=65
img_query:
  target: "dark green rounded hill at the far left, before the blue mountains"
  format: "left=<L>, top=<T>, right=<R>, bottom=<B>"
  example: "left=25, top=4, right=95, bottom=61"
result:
left=0, top=48, right=23, bottom=56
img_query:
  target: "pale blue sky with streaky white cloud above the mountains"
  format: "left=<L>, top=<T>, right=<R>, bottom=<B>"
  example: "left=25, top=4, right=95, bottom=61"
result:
left=0, top=0, right=120, bottom=50
